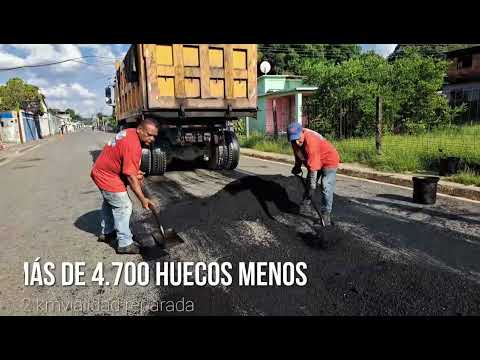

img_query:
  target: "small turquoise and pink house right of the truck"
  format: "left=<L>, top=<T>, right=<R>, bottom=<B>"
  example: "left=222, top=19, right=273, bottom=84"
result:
left=247, top=75, right=317, bottom=135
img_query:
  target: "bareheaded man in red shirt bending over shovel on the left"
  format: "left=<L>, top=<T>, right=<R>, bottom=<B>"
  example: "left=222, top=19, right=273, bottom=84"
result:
left=91, top=119, right=158, bottom=254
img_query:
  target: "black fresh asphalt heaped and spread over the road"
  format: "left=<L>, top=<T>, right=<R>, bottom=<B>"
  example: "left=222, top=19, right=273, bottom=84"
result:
left=129, top=163, right=480, bottom=315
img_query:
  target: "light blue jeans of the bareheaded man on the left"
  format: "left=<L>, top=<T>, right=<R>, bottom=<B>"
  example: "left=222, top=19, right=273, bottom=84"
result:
left=100, top=189, right=133, bottom=247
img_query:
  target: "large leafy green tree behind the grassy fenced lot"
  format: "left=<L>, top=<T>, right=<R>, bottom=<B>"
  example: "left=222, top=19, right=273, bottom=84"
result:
left=300, top=48, right=461, bottom=136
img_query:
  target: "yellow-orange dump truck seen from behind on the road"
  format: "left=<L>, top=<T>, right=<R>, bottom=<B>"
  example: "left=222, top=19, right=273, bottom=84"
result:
left=106, top=44, right=257, bottom=175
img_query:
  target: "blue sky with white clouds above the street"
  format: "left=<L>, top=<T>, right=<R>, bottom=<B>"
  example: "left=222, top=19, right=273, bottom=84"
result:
left=0, top=44, right=396, bottom=117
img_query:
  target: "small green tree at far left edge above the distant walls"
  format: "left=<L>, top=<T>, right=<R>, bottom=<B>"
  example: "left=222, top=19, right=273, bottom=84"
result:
left=0, top=78, right=41, bottom=111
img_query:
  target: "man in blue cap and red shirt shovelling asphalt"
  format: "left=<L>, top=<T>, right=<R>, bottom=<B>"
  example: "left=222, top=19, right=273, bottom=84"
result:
left=287, top=122, right=340, bottom=226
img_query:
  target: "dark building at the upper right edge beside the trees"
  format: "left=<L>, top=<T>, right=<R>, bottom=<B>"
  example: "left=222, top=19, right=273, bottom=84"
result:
left=443, top=46, right=480, bottom=121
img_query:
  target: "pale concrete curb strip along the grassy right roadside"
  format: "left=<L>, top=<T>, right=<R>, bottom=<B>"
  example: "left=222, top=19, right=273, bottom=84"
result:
left=241, top=148, right=480, bottom=201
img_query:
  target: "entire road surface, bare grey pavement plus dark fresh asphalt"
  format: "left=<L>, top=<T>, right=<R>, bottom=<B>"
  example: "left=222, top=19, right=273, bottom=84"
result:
left=0, top=132, right=480, bottom=315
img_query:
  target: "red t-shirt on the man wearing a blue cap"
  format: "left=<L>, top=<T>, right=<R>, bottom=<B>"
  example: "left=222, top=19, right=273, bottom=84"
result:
left=292, top=129, right=340, bottom=171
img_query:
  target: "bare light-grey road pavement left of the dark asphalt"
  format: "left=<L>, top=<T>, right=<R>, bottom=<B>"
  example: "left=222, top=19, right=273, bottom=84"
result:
left=0, top=132, right=157, bottom=315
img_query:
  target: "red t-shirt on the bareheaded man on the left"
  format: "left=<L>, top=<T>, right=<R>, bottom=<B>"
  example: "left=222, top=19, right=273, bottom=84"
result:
left=90, top=129, right=142, bottom=192
